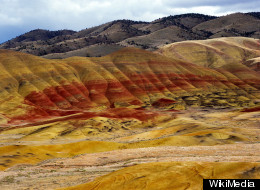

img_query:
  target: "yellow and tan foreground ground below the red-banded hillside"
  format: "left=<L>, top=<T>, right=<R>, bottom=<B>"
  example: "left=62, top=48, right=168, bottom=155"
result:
left=0, top=108, right=260, bottom=190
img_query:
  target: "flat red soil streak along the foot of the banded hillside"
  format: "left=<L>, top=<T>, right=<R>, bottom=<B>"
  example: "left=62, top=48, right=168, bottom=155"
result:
left=8, top=108, right=161, bottom=128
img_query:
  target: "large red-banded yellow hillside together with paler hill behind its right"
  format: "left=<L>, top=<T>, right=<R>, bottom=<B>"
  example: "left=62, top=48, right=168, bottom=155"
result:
left=0, top=38, right=260, bottom=127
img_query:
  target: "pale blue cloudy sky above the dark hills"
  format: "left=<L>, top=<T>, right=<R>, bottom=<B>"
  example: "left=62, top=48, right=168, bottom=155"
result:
left=0, top=0, right=260, bottom=43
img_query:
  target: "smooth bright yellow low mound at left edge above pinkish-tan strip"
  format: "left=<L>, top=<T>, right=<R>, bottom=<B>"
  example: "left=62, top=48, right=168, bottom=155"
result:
left=0, top=141, right=121, bottom=170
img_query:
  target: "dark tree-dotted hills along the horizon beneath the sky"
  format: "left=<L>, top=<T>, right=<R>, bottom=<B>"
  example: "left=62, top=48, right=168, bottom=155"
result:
left=0, top=12, right=260, bottom=58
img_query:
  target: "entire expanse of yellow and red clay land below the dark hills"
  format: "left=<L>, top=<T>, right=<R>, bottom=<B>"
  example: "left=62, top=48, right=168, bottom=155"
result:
left=0, top=37, right=260, bottom=190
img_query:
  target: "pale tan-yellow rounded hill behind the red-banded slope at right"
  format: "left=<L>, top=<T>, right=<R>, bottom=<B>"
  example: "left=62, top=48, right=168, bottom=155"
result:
left=157, top=37, right=260, bottom=69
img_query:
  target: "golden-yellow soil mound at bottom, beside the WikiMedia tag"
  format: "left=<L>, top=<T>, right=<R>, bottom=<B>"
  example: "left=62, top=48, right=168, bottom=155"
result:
left=62, top=162, right=260, bottom=190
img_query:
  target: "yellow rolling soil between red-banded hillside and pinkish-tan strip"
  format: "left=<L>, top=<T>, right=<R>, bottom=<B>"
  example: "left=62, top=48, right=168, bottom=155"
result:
left=0, top=109, right=260, bottom=170
